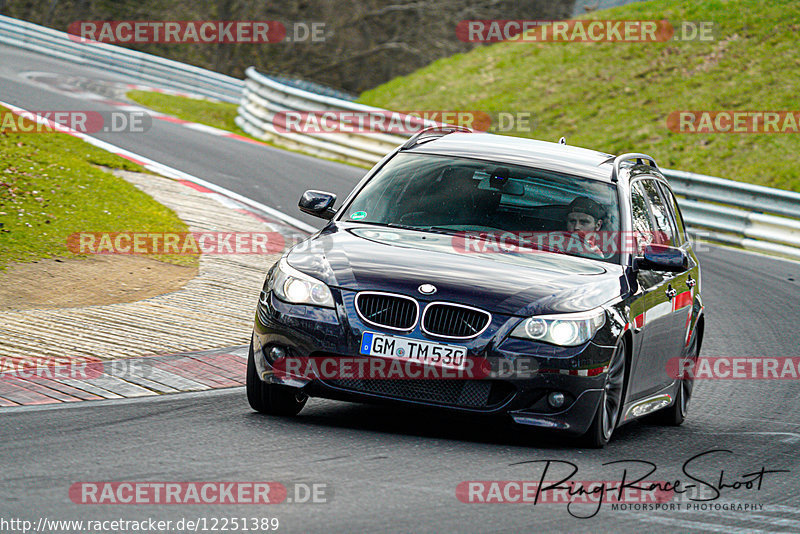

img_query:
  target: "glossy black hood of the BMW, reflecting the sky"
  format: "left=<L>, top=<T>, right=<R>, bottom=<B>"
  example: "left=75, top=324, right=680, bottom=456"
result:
left=287, top=224, right=627, bottom=315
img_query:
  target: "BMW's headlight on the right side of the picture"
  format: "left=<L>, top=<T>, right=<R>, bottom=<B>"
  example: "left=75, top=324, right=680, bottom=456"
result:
left=511, top=308, right=606, bottom=347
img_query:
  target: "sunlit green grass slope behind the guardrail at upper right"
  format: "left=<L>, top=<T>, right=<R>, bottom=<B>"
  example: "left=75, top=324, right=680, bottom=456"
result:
left=360, top=0, right=800, bottom=191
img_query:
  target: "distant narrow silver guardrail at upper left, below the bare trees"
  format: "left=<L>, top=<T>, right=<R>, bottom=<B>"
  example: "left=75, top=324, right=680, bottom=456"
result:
left=0, top=15, right=244, bottom=102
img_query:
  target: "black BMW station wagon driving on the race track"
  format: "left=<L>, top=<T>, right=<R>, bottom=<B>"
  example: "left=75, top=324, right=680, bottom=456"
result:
left=247, top=128, right=704, bottom=447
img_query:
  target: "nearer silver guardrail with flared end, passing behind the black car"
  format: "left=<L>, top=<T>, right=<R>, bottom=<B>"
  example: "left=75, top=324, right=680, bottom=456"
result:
left=236, top=67, right=800, bottom=259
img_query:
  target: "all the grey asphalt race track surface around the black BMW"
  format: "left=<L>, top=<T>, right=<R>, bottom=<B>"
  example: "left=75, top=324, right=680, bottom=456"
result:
left=0, top=47, right=800, bottom=533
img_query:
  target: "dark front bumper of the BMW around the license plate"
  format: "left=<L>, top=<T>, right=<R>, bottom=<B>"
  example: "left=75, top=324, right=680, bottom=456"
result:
left=253, top=291, right=614, bottom=434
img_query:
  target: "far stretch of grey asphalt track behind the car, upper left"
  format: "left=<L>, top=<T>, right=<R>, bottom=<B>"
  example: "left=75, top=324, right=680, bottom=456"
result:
left=0, top=46, right=364, bottom=227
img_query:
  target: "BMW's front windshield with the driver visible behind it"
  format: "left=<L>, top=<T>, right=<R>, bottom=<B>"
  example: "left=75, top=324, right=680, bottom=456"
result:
left=340, top=153, right=619, bottom=262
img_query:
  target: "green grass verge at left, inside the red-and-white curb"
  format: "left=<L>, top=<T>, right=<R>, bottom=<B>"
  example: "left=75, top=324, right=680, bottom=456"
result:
left=0, top=108, right=197, bottom=269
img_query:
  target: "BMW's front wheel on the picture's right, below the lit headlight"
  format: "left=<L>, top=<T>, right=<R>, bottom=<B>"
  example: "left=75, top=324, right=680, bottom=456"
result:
left=580, top=340, right=626, bottom=449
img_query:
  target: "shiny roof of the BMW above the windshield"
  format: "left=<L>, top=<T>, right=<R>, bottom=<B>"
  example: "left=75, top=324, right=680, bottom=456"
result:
left=406, top=132, right=614, bottom=183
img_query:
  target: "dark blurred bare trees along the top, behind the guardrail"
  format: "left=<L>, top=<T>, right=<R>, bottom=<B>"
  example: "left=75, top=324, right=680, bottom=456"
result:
left=0, top=0, right=575, bottom=93
